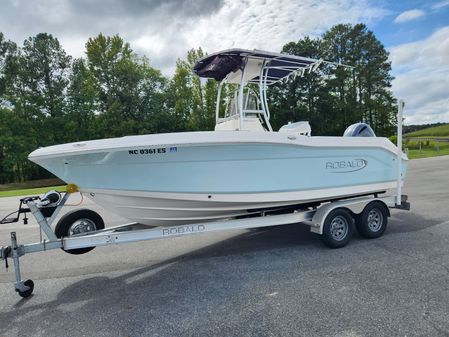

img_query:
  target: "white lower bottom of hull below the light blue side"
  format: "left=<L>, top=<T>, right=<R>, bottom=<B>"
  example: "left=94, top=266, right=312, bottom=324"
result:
left=83, top=182, right=395, bottom=226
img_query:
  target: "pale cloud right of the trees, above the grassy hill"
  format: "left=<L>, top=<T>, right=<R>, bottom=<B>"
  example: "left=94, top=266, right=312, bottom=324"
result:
left=390, top=26, right=449, bottom=124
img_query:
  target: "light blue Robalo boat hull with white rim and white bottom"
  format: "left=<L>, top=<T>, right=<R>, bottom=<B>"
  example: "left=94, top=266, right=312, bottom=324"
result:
left=30, top=132, right=406, bottom=225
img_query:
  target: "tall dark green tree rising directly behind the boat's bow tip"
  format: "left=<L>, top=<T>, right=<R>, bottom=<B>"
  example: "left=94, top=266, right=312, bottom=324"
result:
left=9, top=33, right=71, bottom=145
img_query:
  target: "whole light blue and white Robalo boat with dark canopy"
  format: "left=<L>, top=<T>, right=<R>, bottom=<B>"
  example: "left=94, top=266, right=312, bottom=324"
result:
left=29, top=49, right=407, bottom=226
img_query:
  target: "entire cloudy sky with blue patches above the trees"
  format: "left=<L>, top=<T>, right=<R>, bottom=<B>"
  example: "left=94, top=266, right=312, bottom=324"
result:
left=0, top=0, right=449, bottom=124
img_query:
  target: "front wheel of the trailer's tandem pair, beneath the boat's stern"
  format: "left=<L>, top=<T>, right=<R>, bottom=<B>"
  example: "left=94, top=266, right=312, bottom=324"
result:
left=321, top=208, right=354, bottom=248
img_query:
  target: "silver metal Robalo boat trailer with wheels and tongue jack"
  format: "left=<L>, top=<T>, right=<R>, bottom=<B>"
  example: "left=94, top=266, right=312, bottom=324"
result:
left=0, top=184, right=410, bottom=298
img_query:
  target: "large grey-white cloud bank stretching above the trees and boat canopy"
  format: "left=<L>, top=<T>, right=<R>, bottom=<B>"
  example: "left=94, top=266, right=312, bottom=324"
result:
left=0, top=0, right=390, bottom=74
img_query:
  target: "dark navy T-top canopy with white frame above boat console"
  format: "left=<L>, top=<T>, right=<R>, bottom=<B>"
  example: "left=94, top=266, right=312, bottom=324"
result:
left=193, top=49, right=321, bottom=84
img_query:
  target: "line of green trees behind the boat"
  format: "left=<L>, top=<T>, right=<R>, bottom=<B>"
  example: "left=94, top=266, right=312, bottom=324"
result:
left=0, top=24, right=395, bottom=183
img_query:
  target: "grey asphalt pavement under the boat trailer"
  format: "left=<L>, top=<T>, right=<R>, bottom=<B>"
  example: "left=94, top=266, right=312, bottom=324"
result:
left=0, top=156, right=449, bottom=337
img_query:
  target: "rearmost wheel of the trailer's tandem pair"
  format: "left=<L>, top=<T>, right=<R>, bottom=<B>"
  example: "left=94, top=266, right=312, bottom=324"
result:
left=355, top=201, right=388, bottom=239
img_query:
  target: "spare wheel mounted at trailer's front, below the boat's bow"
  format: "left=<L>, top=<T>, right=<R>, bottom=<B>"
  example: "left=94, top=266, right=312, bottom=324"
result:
left=55, top=209, right=104, bottom=255
